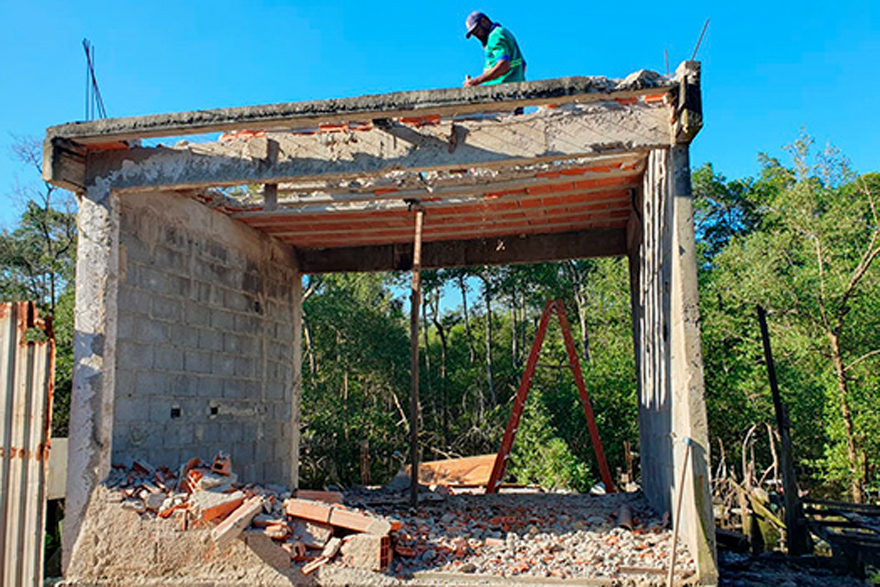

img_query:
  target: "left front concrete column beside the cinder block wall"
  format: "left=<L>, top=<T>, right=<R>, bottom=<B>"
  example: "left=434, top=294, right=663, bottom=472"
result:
left=62, top=183, right=119, bottom=570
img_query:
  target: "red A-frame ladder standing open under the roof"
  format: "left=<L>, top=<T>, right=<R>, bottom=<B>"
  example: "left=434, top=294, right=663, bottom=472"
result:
left=486, top=300, right=614, bottom=493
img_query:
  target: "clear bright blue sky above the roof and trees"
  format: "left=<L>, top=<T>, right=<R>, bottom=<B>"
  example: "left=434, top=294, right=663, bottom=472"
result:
left=0, top=0, right=880, bottom=225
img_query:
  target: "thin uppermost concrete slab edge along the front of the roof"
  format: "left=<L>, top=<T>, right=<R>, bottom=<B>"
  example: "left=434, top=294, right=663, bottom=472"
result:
left=47, top=70, right=678, bottom=144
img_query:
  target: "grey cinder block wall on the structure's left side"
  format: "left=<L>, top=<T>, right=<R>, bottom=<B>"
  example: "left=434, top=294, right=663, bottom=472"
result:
left=112, top=193, right=300, bottom=483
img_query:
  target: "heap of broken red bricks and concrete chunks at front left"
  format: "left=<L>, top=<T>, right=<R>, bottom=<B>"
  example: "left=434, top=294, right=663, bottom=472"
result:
left=107, top=452, right=400, bottom=574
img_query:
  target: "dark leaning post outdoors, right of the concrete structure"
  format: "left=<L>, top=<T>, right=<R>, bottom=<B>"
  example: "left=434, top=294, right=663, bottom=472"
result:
left=758, top=306, right=810, bottom=555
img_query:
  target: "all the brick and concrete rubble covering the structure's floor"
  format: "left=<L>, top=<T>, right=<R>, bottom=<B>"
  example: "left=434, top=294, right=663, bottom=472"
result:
left=96, top=453, right=695, bottom=583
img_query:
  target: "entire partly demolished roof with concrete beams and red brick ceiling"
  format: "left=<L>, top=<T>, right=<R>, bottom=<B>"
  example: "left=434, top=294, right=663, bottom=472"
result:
left=44, top=62, right=701, bottom=272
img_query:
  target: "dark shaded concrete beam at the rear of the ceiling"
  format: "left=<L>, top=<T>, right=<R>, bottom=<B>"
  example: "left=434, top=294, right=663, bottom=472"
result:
left=298, top=228, right=626, bottom=273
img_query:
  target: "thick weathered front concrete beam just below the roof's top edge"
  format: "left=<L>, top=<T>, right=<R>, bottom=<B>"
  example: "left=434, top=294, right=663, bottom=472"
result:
left=70, top=102, right=672, bottom=191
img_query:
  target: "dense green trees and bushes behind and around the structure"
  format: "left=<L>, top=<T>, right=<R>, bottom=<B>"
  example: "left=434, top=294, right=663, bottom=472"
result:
left=0, top=137, right=880, bottom=500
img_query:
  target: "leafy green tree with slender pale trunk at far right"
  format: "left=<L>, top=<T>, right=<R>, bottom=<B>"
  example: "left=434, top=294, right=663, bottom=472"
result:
left=709, top=137, right=880, bottom=502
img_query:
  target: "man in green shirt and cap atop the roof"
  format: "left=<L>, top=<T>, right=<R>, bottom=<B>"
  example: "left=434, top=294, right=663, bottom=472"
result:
left=464, top=12, right=526, bottom=87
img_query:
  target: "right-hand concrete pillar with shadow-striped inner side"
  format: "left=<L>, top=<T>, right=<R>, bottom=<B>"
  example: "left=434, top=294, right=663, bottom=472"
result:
left=628, top=144, right=717, bottom=584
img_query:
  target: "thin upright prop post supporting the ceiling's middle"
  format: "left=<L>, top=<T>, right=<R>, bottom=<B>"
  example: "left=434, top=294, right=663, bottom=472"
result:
left=409, top=208, right=425, bottom=506
